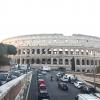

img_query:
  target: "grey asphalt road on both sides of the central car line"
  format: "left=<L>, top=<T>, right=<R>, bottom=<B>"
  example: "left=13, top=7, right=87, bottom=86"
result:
left=28, top=72, right=79, bottom=100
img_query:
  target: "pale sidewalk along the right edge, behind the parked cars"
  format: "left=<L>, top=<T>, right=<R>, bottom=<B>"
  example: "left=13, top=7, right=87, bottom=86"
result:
left=75, top=74, right=100, bottom=91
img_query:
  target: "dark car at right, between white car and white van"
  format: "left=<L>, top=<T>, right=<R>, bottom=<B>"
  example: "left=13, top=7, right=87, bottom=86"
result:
left=80, top=85, right=95, bottom=94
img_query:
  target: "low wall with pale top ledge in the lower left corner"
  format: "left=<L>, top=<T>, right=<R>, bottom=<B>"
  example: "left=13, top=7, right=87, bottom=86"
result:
left=0, top=72, right=32, bottom=100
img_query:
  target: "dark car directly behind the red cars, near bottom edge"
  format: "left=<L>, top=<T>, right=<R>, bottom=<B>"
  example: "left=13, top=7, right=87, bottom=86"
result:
left=38, top=90, right=50, bottom=100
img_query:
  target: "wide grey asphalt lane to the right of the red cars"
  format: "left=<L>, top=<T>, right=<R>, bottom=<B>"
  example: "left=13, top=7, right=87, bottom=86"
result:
left=44, top=73, right=79, bottom=100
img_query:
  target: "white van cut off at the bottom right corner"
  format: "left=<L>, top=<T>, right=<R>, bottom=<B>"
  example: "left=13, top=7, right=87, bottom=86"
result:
left=75, top=94, right=100, bottom=100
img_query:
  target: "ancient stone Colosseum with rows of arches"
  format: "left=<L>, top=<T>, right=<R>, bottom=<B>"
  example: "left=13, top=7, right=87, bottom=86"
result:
left=2, top=34, right=100, bottom=72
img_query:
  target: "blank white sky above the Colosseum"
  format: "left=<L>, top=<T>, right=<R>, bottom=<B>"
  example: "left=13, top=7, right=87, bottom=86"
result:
left=0, top=0, right=100, bottom=41
